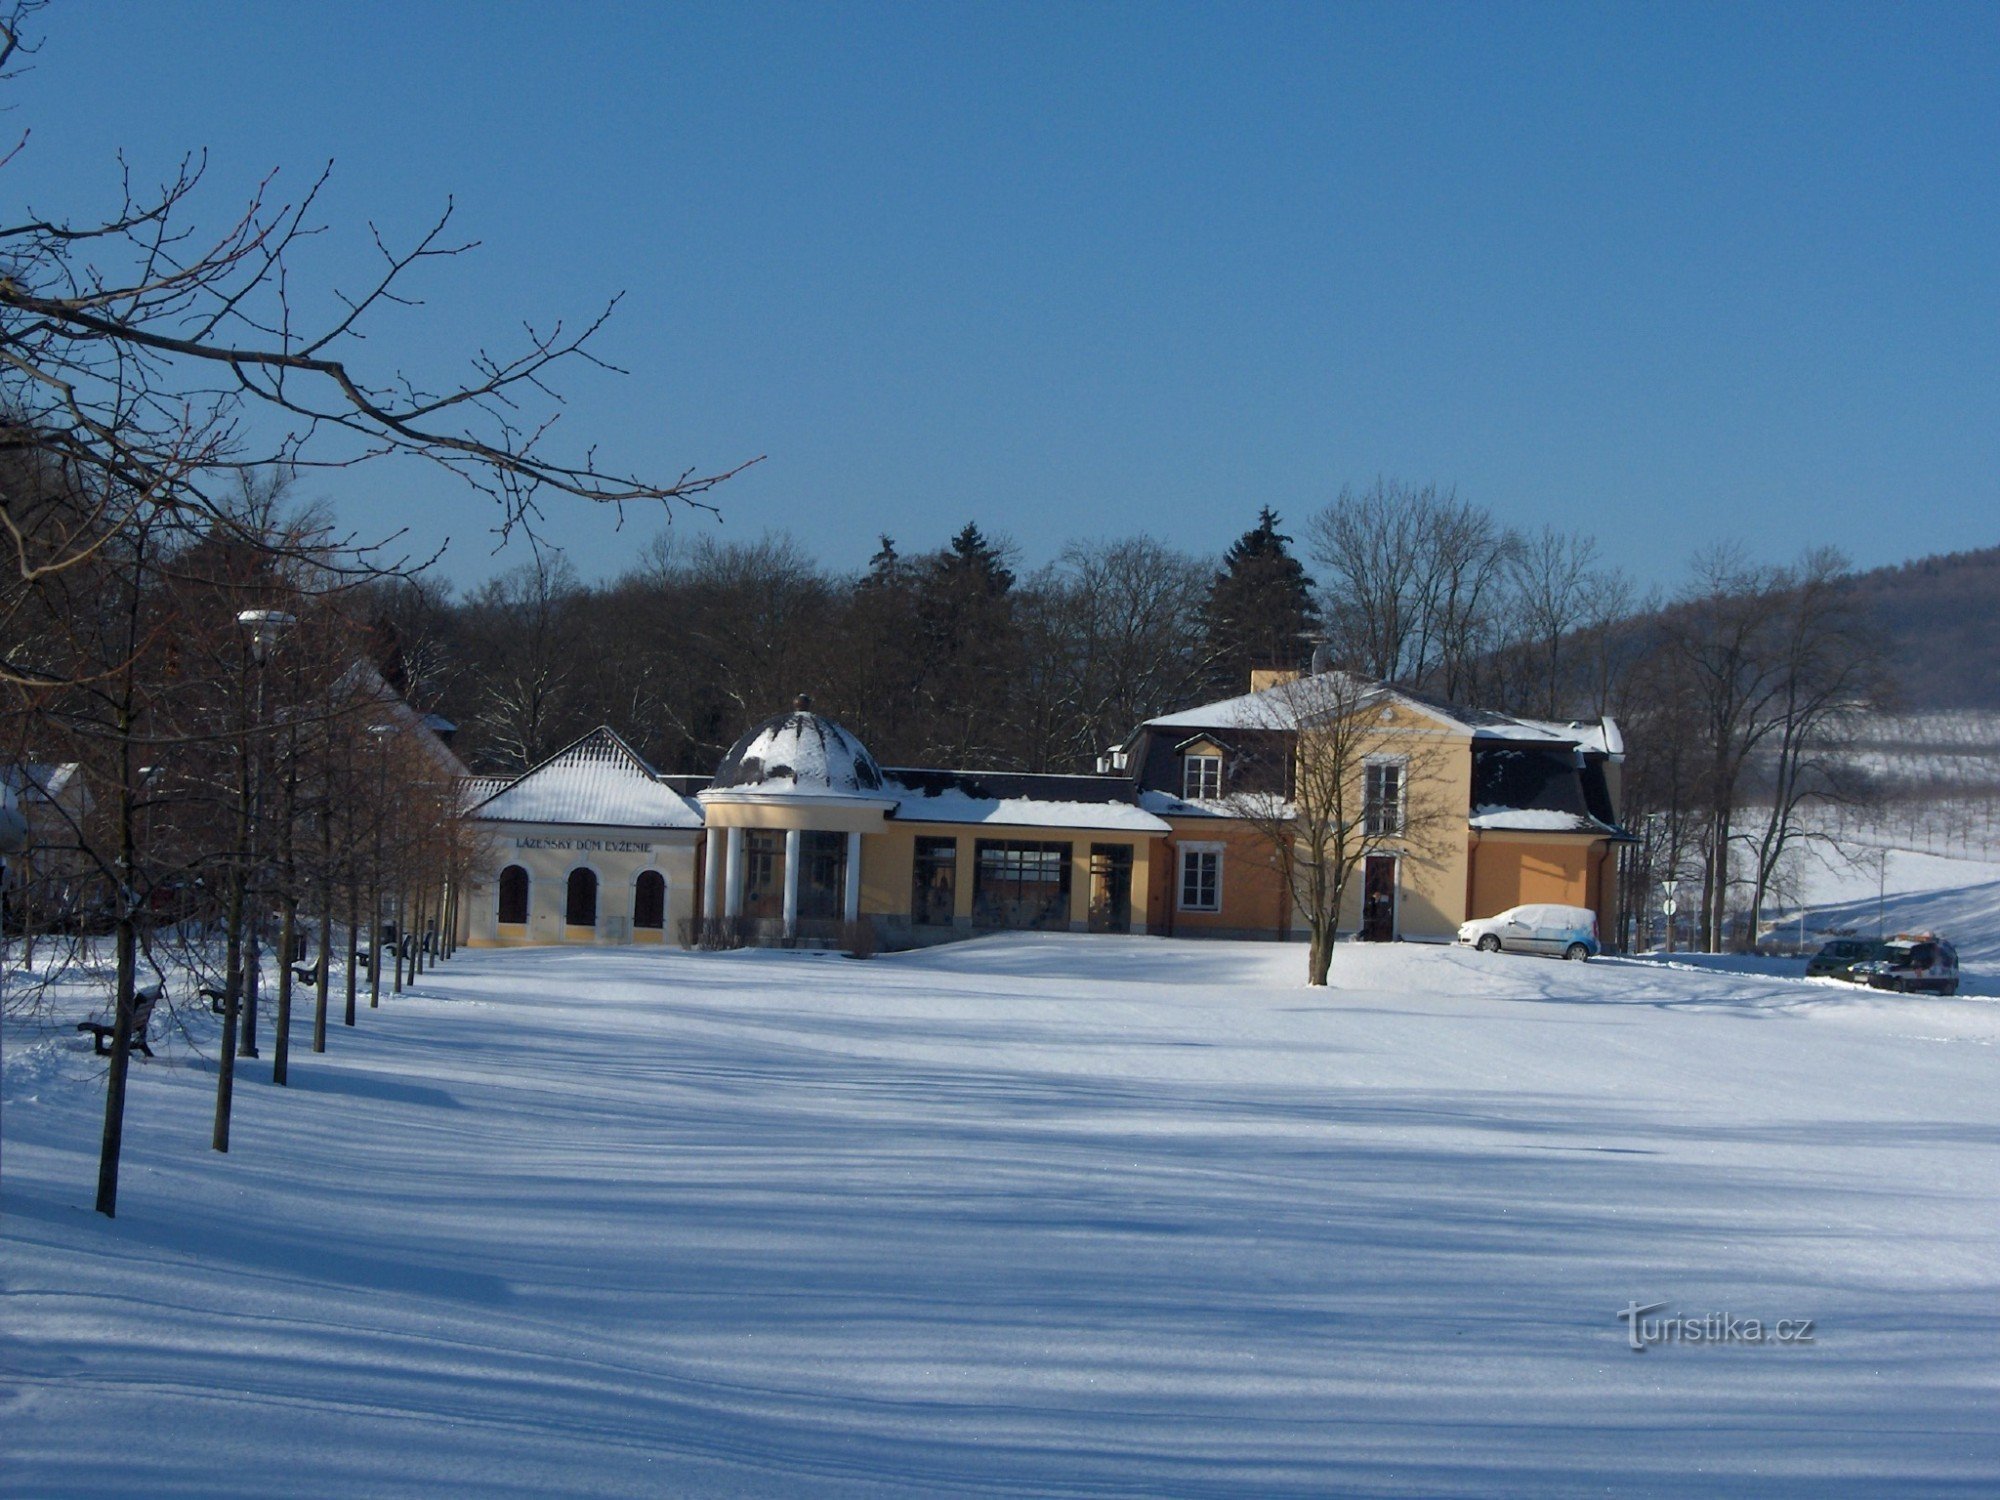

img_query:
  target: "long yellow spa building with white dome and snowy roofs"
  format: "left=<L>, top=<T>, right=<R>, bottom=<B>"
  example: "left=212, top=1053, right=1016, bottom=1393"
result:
left=462, top=674, right=1626, bottom=948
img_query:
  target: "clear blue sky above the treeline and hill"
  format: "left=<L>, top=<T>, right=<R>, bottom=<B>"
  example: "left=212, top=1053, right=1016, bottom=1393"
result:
left=6, top=0, right=2000, bottom=582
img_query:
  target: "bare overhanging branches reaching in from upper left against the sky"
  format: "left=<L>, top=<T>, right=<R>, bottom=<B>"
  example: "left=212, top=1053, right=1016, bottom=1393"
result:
left=0, top=6, right=752, bottom=680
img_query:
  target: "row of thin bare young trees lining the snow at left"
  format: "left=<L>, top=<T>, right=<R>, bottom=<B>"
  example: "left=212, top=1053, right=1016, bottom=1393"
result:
left=0, top=448, right=474, bottom=1214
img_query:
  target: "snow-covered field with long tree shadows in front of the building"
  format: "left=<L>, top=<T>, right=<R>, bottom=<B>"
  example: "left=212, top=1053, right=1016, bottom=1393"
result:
left=0, top=936, right=2000, bottom=1496
